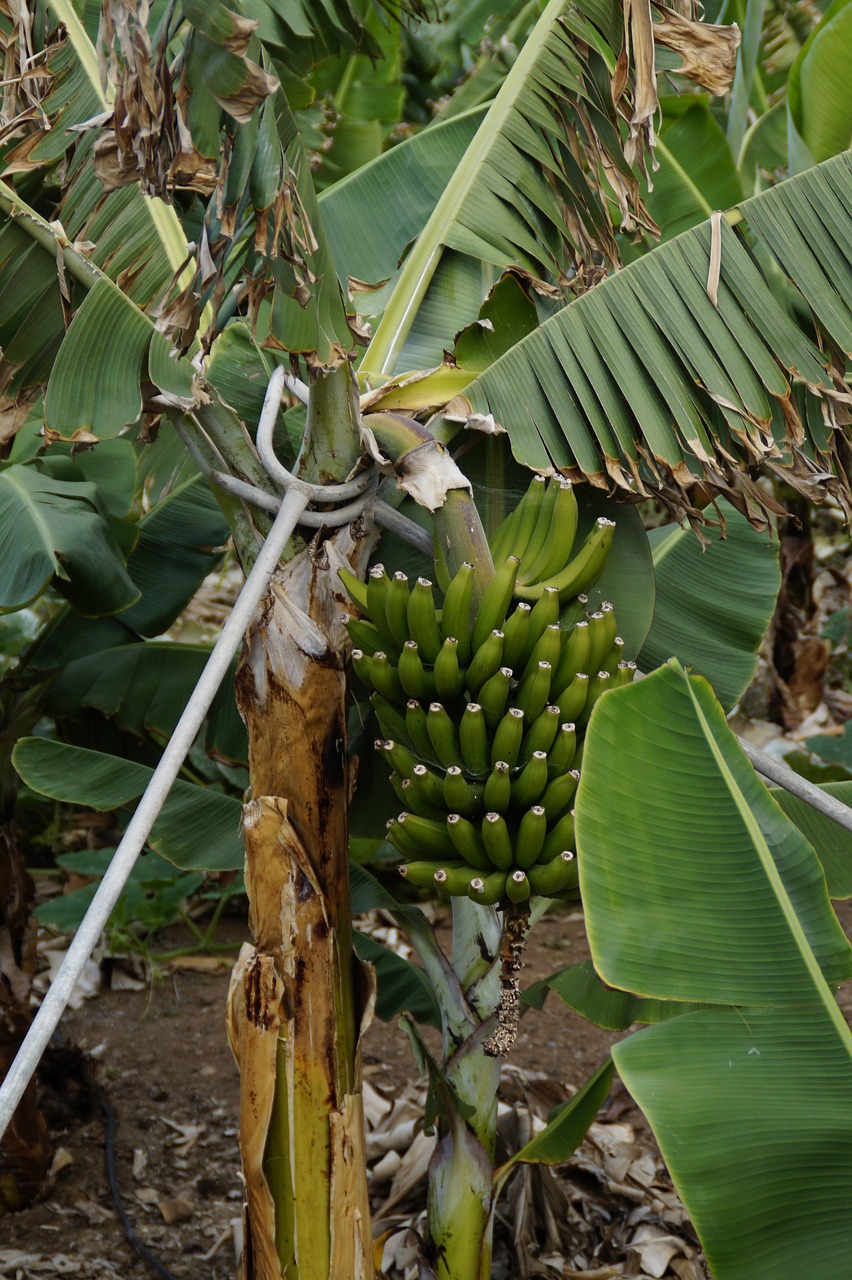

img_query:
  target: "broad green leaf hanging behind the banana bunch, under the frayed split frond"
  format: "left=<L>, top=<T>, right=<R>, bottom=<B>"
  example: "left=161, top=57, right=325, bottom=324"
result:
left=638, top=502, right=780, bottom=710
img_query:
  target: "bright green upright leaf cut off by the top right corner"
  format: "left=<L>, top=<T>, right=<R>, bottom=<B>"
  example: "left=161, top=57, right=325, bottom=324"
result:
left=787, top=0, right=852, bottom=173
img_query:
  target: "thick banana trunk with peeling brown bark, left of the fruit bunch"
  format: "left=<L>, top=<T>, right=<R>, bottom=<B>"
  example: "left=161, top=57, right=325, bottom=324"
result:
left=228, top=530, right=374, bottom=1280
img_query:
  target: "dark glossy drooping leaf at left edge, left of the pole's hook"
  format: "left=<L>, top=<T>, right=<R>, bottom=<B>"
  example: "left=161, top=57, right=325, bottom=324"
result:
left=0, top=462, right=139, bottom=617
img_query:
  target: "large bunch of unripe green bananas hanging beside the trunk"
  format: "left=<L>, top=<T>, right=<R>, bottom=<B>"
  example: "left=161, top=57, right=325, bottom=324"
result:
left=340, top=477, right=636, bottom=906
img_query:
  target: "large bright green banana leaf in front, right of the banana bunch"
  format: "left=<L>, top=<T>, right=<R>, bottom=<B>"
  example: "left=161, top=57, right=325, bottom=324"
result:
left=576, top=664, right=852, bottom=1280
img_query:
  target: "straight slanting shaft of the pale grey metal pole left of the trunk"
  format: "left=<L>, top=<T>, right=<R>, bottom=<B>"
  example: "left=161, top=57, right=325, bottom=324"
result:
left=0, top=481, right=310, bottom=1137
